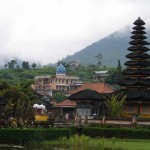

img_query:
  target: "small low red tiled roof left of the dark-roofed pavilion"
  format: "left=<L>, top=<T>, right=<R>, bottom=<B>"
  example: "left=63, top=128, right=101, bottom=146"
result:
left=54, top=99, right=77, bottom=107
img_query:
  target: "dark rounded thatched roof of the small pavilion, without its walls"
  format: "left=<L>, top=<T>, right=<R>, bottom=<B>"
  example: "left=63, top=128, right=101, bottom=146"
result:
left=68, top=89, right=105, bottom=101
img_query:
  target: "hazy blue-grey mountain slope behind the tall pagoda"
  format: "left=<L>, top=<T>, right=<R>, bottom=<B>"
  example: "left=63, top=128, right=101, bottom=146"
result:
left=62, top=27, right=150, bottom=67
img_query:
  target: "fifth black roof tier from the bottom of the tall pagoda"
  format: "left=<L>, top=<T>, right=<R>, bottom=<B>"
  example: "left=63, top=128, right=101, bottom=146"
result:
left=126, top=53, right=150, bottom=59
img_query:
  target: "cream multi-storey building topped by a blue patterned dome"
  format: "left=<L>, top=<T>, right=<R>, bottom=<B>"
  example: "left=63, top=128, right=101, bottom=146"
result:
left=32, top=64, right=79, bottom=96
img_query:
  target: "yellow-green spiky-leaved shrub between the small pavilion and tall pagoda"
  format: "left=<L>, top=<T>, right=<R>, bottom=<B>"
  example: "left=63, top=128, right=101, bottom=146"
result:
left=105, top=94, right=126, bottom=117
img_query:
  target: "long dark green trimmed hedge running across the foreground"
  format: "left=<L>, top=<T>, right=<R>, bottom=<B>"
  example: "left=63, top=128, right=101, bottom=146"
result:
left=0, top=127, right=150, bottom=145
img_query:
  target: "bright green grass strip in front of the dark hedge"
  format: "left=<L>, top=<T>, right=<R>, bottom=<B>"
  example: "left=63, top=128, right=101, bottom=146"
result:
left=31, top=135, right=150, bottom=150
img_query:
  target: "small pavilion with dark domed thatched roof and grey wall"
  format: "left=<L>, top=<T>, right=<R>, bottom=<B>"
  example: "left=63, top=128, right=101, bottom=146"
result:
left=68, top=89, right=105, bottom=119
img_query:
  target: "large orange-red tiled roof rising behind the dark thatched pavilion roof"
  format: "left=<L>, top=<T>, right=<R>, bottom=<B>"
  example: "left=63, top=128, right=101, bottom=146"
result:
left=70, top=82, right=114, bottom=94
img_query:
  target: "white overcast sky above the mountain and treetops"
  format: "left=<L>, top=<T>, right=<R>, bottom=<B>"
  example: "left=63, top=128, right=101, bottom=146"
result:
left=0, top=0, right=150, bottom=65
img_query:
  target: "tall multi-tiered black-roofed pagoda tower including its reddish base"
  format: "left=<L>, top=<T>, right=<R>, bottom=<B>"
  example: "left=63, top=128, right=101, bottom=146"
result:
left=117, top=17, right=150, bottom=118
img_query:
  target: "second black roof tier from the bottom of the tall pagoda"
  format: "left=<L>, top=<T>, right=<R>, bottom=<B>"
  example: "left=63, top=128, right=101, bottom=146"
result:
left=119, top=78, right=150, bottom=87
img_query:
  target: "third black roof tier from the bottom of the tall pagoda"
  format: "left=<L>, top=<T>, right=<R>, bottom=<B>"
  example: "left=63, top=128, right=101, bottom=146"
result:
left=122, top=69, right=150, bottom=76
